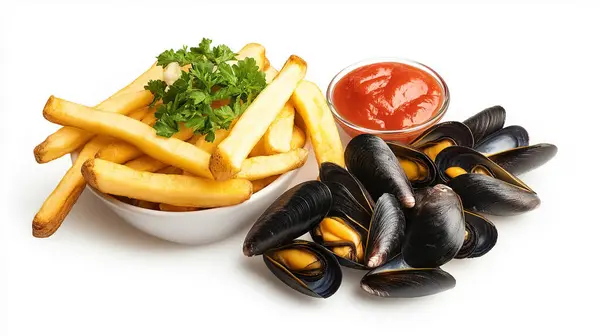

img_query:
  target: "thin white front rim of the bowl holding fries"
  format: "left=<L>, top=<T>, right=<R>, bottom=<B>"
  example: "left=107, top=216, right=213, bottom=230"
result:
left=71, top=140, right=312, bottom=217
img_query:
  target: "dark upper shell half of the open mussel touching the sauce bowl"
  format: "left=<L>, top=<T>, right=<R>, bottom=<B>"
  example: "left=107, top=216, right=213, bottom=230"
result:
left=410, top=121, right=473, bottom=149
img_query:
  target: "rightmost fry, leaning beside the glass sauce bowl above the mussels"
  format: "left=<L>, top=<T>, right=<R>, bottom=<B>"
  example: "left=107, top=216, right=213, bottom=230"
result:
left=292, top=80, right=345, bottom=167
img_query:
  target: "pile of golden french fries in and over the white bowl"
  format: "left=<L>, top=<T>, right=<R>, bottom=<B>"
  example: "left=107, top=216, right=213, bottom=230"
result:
left=32, top=43, right=344, bottom=238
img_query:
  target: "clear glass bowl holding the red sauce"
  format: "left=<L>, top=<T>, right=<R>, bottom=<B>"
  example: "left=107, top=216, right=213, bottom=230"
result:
left=326, top=57, right=450, bottom=143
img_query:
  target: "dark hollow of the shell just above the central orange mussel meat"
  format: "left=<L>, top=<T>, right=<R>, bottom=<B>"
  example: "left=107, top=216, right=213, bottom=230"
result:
left=325, top=182, right=373, bottom=230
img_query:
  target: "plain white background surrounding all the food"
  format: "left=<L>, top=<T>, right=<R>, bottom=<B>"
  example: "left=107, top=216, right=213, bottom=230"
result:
left=0, top=1, right=600, bottom=336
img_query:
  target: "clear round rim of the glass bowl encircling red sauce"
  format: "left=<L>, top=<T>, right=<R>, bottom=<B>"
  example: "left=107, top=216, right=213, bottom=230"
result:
left=326, top=57, right=450, bottom=135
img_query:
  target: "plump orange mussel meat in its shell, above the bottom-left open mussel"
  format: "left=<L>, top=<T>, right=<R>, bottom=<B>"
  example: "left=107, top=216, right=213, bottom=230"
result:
left=310, top=216, right=368, bottom=270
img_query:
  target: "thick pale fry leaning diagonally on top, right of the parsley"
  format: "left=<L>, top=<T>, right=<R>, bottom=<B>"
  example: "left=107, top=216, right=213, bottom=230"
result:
left=209, top=55, right=306, bottom=180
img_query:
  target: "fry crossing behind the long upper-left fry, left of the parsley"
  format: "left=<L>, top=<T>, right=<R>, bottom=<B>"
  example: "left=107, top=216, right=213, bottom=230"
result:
left=33, top=63, right=163, bottom=163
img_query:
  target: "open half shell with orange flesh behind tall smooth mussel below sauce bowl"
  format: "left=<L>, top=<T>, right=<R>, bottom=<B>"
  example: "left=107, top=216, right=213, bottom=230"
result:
left=388, top=142, right=437, bottom=188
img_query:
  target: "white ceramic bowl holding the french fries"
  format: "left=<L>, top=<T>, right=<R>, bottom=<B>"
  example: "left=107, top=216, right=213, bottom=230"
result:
left=71, top=144, right=310, bottom=245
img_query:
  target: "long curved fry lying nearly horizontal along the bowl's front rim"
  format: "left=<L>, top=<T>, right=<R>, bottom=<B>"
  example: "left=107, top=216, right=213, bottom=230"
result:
left=81, top=159, right=252, bottom=208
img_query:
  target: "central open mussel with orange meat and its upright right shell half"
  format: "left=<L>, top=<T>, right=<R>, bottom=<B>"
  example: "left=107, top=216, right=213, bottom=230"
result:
left=311, top=193, right=406, bottom=269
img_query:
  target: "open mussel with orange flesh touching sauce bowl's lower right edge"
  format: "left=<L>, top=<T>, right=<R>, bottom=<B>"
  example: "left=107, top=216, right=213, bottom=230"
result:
left=410, top=121, right=473, bottom=161
